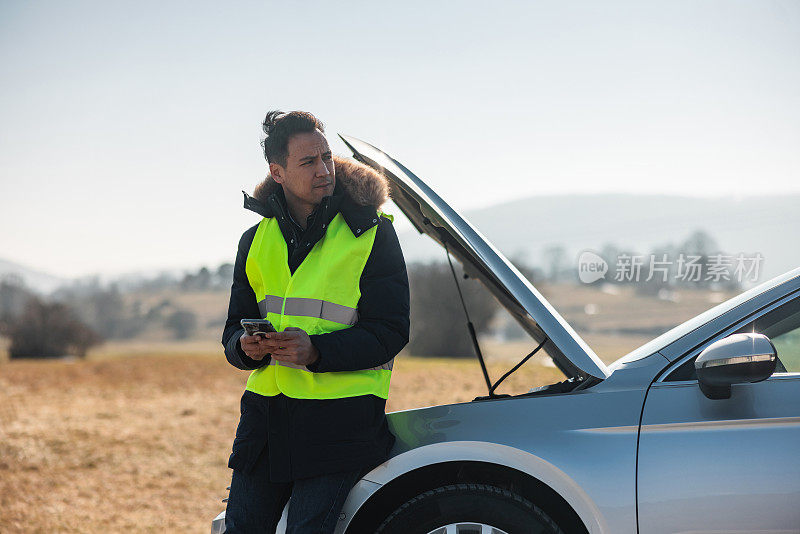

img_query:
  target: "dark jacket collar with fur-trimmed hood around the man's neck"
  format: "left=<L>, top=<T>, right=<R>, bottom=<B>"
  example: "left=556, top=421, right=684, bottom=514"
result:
left=242, top=156, right=389, bottom=237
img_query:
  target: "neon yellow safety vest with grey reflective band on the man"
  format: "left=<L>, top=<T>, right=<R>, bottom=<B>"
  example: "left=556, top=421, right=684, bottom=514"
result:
left=245, top=213, right=393, bottom=399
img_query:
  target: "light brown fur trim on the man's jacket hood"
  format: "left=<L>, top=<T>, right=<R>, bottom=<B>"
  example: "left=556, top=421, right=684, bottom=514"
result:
left=253, top=156, right=389, bottom=210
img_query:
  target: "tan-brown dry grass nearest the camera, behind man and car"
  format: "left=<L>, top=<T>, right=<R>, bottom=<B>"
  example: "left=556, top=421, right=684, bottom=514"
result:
left=0, top=351, right=560, bottom=532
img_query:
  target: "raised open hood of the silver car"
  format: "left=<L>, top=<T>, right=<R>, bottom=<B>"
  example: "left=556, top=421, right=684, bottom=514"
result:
left=340, top=135, right=610, bottom=380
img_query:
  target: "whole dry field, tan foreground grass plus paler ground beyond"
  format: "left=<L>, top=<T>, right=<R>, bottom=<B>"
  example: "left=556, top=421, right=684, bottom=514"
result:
left=0, top=286, right=729, bottom=533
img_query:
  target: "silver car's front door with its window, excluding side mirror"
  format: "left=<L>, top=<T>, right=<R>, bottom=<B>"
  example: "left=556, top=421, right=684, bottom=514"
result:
left=637, top=295, right=800, bottom=534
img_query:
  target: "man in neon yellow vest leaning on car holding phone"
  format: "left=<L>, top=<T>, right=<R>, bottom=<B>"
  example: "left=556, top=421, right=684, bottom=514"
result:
left=222, top=111, right=409, bottom=534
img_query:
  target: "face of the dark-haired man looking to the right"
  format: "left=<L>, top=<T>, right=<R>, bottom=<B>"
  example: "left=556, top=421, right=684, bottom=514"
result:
left=269, top=130, right=336, bottom=209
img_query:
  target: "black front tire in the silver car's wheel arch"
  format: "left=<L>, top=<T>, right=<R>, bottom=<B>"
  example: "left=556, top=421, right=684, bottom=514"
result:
left=375, top=484, right=564, bottom=534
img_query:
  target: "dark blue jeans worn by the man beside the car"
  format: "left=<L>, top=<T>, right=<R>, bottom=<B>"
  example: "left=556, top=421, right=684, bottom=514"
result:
left=225, top=454, right=362, bottom=534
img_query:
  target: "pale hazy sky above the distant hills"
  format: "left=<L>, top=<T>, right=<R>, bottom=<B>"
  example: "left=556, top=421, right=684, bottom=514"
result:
left=0, top=0, right=800, bottom=276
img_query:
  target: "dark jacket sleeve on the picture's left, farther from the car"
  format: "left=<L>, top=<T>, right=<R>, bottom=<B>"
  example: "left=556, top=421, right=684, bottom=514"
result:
left=222, top=225, right=270, bottom=369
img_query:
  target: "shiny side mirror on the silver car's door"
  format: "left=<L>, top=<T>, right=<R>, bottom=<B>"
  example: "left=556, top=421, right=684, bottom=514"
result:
left=694, top=334, right=778, bottom=399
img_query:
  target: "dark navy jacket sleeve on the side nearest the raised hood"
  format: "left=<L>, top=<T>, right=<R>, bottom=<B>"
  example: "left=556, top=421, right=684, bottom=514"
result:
left=307, top=217, right=410, bottom=373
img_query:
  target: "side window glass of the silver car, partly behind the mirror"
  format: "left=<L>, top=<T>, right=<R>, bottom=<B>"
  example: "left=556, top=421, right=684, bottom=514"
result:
left=666, top=298, right=800, bottom=382
